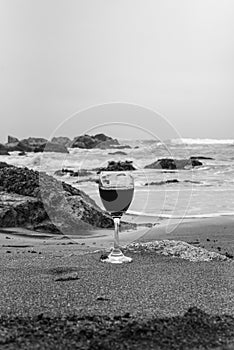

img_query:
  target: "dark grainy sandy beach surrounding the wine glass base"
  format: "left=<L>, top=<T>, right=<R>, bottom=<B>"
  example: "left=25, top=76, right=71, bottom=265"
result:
left=0, top=217, right=234, bottom=349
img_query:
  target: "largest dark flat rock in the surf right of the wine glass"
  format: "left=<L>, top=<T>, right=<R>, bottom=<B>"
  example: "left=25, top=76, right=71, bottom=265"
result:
left=145, top=158, right=202, bottom=170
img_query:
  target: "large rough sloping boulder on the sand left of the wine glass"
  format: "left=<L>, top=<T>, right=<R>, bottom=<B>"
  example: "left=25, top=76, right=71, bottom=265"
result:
left=0, top=164, right=113, bottom=234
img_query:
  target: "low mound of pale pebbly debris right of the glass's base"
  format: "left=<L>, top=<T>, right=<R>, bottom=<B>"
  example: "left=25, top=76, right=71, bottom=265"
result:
left=124, top=239, right=230, bottom=262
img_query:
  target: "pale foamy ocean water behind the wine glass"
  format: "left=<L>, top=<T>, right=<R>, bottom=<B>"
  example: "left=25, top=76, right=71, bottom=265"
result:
left=1, top=139, right=234, bottom=222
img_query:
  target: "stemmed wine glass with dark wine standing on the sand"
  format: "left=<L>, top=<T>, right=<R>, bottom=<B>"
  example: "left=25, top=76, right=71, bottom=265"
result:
left=99, top=171, right=134, bottom=264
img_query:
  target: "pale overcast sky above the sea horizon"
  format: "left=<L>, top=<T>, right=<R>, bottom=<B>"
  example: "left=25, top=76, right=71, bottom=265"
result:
left=0, top=0, right=234, bottom=142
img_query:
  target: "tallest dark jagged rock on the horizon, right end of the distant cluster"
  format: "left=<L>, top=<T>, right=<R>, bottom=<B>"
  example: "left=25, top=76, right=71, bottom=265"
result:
left=71, top=134, right=119, bottom=149
